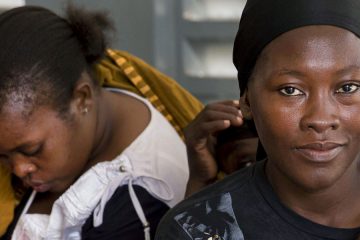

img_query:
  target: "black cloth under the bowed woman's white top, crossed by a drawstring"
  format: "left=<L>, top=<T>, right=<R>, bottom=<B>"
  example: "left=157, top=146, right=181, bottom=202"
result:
left=82, top=185, right=169, bottom=240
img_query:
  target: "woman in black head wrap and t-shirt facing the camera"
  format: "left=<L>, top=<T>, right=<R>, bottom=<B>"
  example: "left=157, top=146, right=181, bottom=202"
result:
left=157, top=0, right=360, bottom=240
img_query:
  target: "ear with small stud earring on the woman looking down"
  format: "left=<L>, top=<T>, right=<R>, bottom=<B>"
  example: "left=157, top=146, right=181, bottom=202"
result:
left=71, top=73, right=94, bottom=114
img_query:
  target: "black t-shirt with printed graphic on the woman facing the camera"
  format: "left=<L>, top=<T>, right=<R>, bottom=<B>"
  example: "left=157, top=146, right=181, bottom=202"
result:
left=155, top=161, right=360, bottom=240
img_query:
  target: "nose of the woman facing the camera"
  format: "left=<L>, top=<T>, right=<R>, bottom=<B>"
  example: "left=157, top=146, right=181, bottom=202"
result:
left=300, top=95, right=340, bottom=133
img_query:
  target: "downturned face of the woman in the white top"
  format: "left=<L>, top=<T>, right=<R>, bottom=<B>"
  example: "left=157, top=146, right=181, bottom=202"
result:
left=0, top=100, right=93, bottom=193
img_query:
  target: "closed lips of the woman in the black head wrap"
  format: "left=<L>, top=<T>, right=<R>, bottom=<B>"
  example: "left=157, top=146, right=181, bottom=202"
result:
left=295, top=142, right=344, bottom=163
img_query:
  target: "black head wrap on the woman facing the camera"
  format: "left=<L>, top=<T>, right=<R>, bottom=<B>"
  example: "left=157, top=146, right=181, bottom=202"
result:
left=233, top=0, right=360, bottom=93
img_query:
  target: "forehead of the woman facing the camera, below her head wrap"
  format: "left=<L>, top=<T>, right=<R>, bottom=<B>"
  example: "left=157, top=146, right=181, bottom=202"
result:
left=254, top=26, right=360, bottom=79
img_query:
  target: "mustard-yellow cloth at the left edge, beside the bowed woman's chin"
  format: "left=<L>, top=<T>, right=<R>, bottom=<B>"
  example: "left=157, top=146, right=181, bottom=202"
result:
left=0, top=164, right=17, bottom=236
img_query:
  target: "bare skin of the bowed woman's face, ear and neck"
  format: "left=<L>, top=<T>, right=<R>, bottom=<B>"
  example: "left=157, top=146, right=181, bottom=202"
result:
left=0, top=74, right=150, bottom=213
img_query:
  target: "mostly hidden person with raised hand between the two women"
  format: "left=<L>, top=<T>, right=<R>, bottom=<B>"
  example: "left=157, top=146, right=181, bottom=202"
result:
left=185, top=100, right=258, bottom=196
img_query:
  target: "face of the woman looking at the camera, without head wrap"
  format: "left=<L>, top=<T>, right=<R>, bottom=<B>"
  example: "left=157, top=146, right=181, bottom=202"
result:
left=246, top=26, right=360, bottom=191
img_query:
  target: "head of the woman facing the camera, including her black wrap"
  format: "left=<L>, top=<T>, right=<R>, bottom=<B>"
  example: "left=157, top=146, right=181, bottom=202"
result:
left=234, top=0, right=360, bottom=191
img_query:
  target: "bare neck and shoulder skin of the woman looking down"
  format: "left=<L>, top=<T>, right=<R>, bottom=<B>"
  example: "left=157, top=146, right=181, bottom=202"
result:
left=86, top=89, right=151, bottom=166
